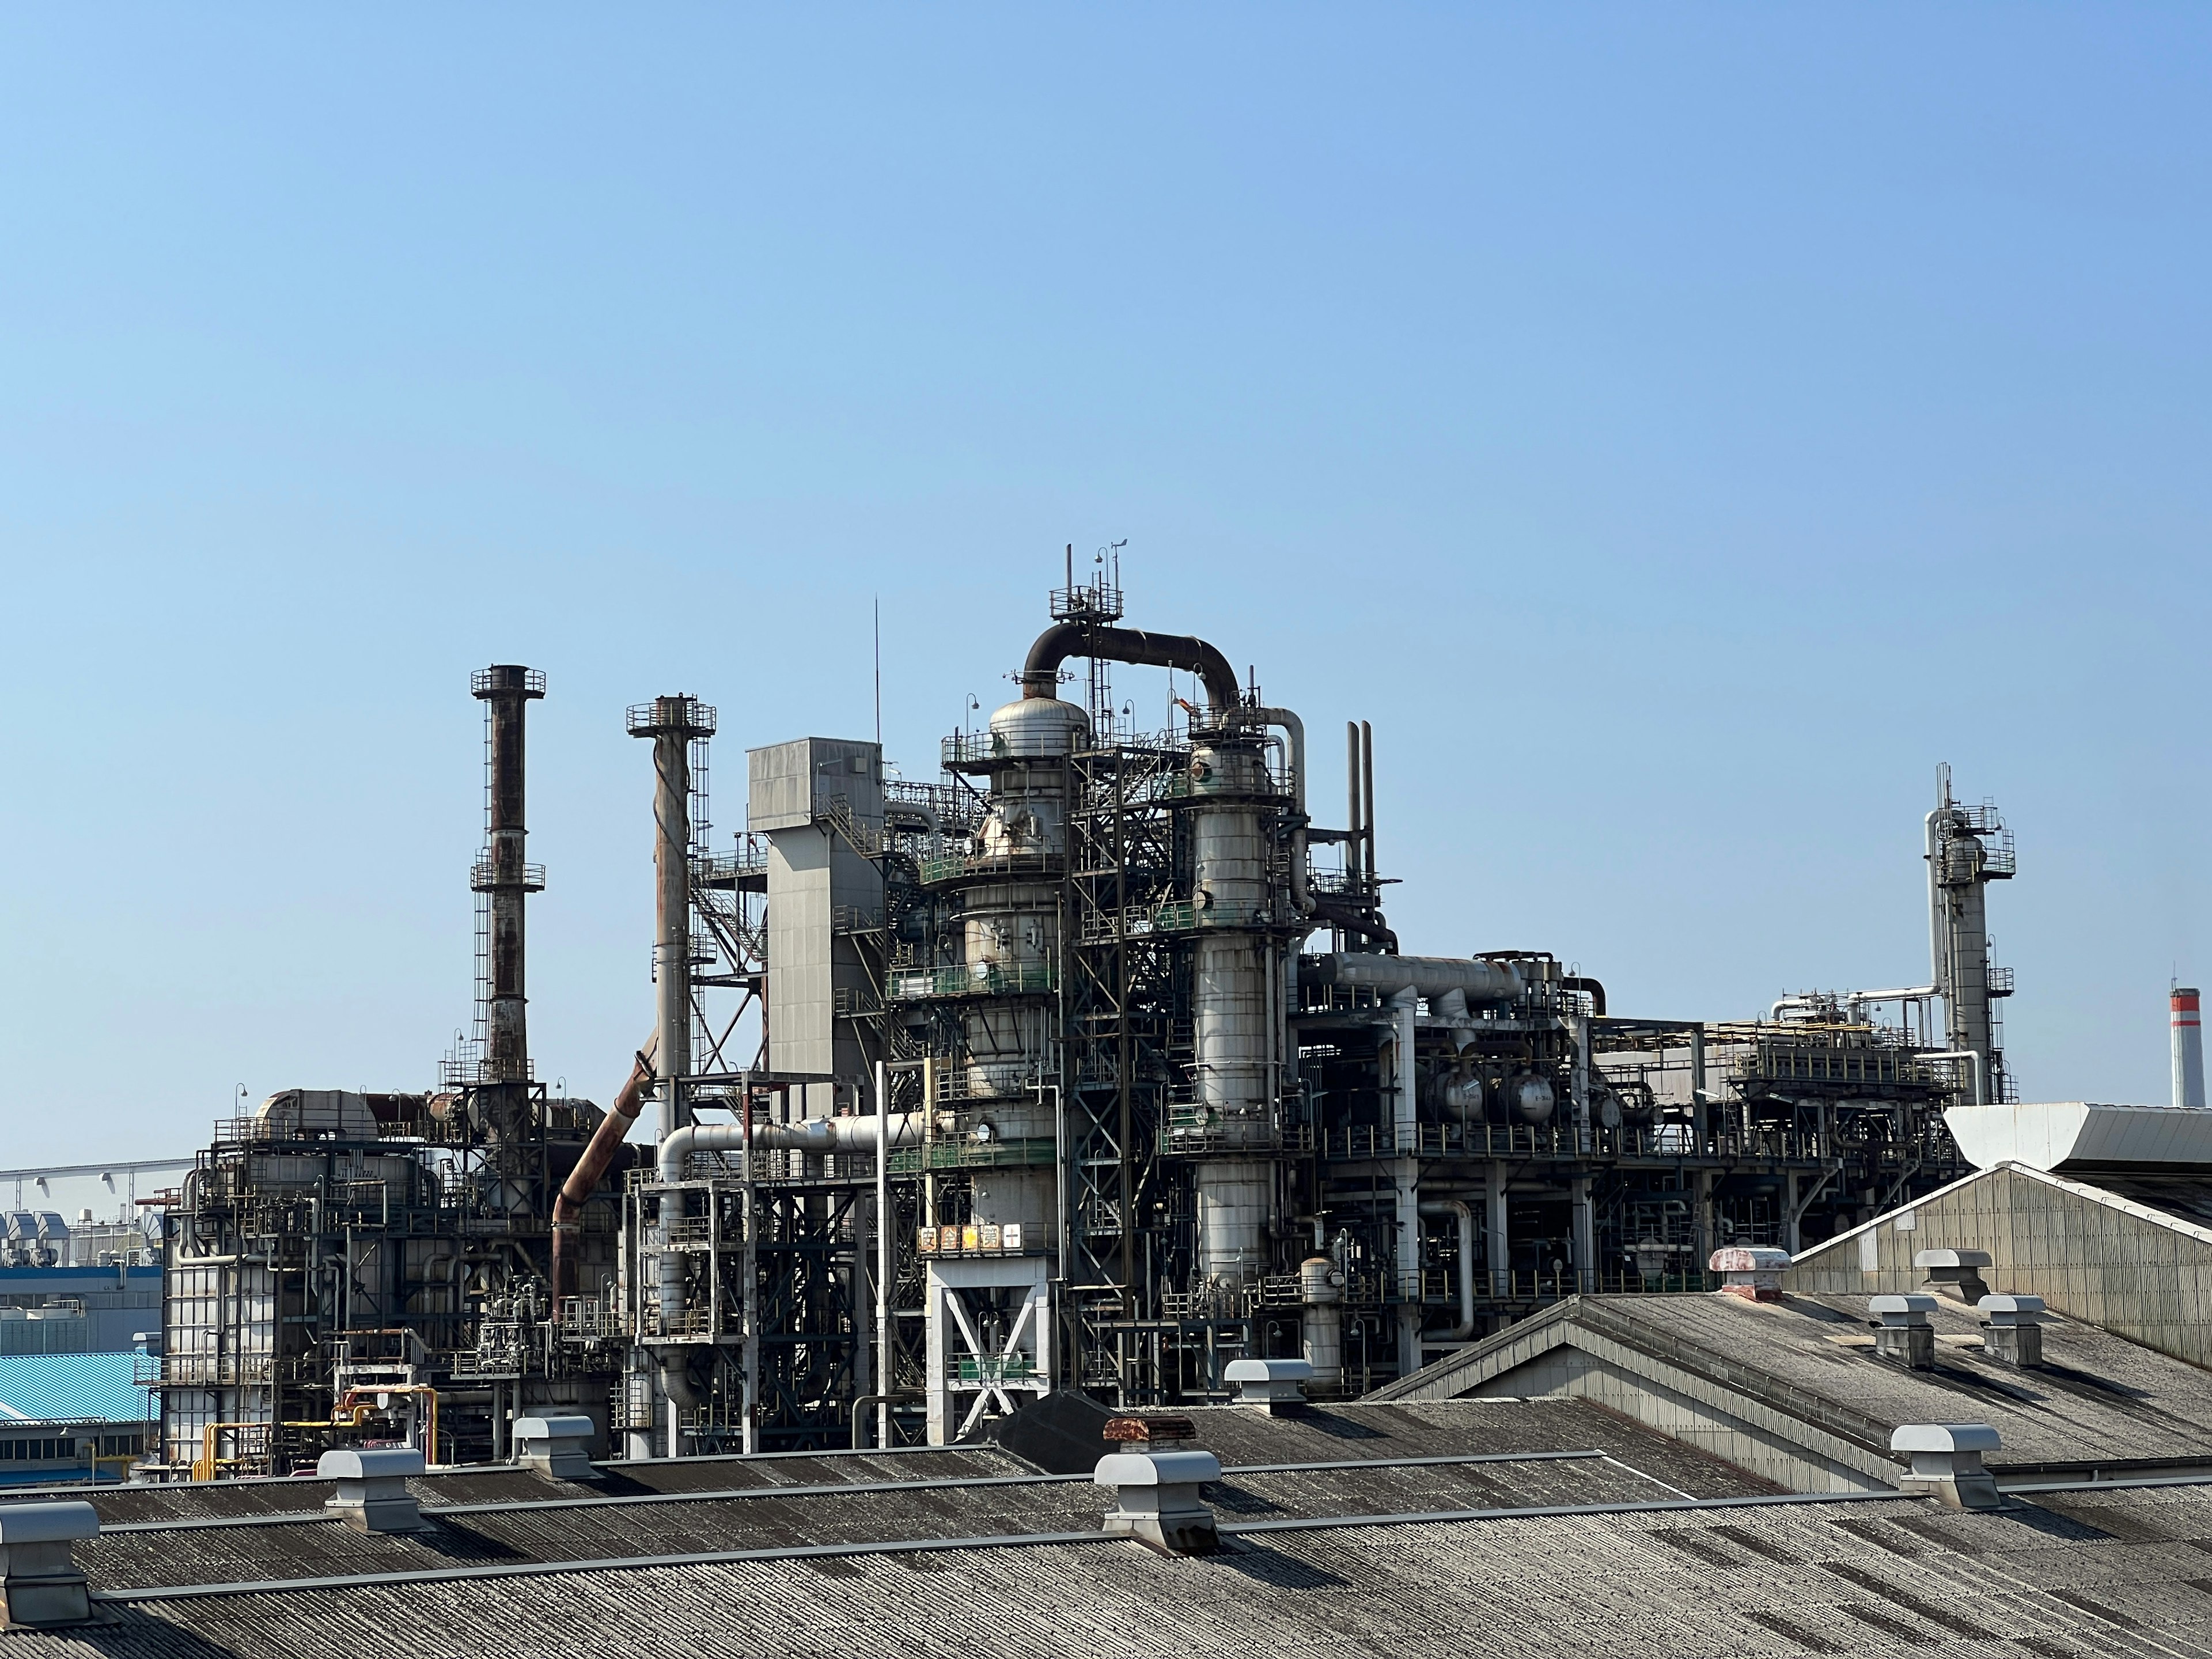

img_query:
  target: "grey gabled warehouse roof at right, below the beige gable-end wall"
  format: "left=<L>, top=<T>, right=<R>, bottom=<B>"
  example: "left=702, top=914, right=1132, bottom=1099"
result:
left=1372, top=1292, right=2212, bottom=1478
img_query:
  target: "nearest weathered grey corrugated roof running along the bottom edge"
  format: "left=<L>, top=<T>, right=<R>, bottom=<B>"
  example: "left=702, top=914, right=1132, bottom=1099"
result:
left=7, top=1484, right=2212, bottom=1659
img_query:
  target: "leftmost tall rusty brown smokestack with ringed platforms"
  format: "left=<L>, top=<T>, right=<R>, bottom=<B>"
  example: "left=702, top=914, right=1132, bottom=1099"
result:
left=469, top=664, right=546, bottom=1106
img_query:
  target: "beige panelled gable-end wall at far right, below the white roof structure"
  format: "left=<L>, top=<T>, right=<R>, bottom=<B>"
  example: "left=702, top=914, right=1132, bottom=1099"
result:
left=1783, top=1161, right=2212, bottom=1367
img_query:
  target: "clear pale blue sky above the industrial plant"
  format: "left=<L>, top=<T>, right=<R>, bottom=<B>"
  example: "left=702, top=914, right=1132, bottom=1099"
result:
left=0, top=7, right=2212, bottom=1164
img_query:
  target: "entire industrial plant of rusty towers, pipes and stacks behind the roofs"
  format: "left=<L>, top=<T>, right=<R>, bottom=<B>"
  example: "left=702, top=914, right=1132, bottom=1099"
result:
left=144, top=562, right=2026, bottom=1480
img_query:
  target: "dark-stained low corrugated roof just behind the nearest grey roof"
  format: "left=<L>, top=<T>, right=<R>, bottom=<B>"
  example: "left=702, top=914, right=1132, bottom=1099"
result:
left=13, top=1400, right=1777, bottom=1586
